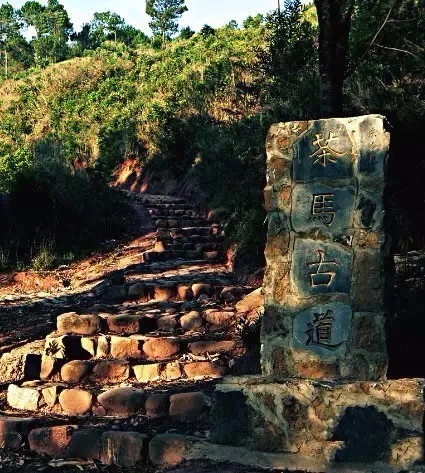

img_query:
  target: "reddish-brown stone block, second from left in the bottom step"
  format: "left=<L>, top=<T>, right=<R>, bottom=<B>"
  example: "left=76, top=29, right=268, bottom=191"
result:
left=28, top=425, right=77, bottom=458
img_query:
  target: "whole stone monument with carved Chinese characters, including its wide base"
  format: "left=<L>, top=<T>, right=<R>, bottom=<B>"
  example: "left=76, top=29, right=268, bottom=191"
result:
left=212, top=115, right=424, bottom=471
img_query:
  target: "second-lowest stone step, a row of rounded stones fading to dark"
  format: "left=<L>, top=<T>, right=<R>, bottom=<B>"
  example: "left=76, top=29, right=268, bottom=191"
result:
left=7, top=382, right=217, bottom=416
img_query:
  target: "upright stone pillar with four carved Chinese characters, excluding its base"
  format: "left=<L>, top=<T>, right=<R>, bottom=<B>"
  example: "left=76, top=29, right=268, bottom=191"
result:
left=262, top=115, right=389, bottom=380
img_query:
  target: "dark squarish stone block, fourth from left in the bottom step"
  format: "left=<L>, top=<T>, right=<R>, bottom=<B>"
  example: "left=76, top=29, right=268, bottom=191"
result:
left=101, top=432, right=147, bottom=468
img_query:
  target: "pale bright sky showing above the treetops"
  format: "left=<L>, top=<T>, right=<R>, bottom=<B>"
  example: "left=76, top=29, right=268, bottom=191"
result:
left=9, top=0, right=277, bottom=34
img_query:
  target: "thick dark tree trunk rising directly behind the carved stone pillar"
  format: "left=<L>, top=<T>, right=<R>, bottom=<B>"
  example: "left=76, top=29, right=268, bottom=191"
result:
left=314, top=0, right=355, bottom=117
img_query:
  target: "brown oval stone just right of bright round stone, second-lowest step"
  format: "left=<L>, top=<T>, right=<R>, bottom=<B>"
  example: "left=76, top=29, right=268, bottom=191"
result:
left=97, top=388, right=145, bottom=416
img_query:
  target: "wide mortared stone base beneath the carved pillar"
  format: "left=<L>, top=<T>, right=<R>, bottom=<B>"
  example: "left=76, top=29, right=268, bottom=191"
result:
left=211, top=376, right=425, bottom=472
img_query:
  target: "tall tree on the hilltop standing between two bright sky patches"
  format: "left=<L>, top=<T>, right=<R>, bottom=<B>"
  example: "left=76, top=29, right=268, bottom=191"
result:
left=146, top=0, right=187, bottom=45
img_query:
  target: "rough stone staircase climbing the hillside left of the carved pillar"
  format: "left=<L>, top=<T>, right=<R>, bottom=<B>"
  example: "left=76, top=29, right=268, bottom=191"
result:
left=0, top=196, right=255, bottom=467
